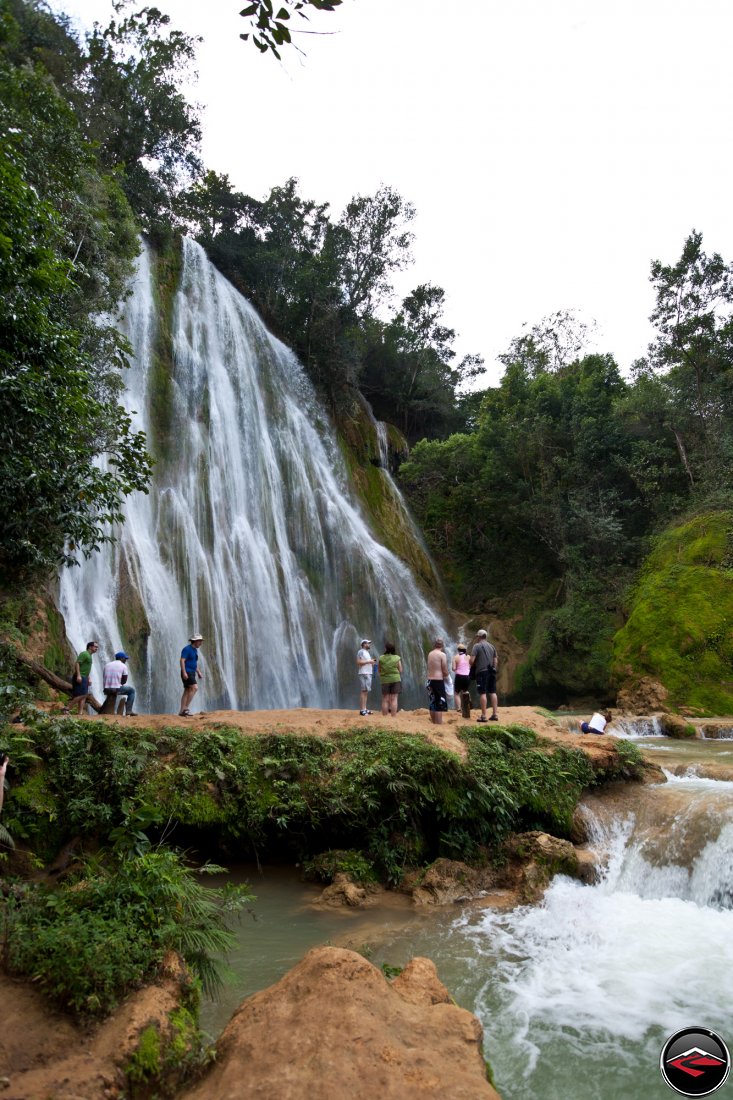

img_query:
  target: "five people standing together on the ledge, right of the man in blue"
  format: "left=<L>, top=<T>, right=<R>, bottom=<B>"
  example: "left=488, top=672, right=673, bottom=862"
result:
left=357, top=630, right=499, bottom=725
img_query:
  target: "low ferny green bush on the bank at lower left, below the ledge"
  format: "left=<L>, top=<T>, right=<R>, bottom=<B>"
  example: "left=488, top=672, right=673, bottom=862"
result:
left=2, top=848, right=244, bottom=1015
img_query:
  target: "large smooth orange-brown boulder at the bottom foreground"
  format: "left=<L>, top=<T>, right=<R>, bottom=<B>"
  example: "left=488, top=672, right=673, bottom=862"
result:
left=182, top=947, right=499, bottom=1100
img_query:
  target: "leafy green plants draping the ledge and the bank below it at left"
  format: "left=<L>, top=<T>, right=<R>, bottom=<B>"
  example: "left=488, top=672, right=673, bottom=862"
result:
left=0, top=706, right=633, bottom=1014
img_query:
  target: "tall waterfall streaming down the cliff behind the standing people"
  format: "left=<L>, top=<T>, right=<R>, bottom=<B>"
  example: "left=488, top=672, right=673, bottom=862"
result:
left=59, top=240, right=442, bottom=712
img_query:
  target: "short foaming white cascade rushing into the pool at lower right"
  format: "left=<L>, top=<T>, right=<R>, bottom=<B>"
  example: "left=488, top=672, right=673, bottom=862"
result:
left=373, top=776, right=733, bottom=1100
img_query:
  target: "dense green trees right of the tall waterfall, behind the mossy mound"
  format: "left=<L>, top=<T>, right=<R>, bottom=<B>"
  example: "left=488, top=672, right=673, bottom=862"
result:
left=401, top=256, right=733, bottom=702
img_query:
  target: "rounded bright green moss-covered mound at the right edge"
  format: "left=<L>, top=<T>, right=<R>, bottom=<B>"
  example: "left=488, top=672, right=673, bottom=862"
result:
left=613, top=512, right=733, bottom=715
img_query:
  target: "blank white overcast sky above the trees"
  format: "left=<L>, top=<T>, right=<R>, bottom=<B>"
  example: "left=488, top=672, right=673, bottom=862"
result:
left=53, top=0, right=733, bottom=384
